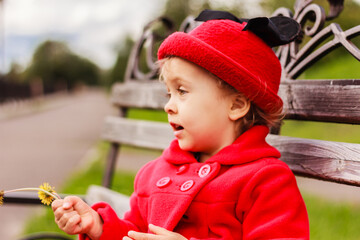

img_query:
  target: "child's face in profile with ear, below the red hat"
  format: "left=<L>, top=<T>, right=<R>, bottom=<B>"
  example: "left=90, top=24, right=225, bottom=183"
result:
left=163, top=58, right=237, bottom=160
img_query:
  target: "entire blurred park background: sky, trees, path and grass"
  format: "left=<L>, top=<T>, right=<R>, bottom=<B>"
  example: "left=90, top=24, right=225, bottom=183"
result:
left=0, top=0, right=360, bottom=240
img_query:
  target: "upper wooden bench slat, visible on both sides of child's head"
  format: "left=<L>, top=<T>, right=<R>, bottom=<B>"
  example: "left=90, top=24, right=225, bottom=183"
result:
left=112, top=79, right=360, bottom=124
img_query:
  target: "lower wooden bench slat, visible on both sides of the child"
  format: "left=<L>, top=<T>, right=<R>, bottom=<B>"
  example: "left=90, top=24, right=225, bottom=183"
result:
left=103, top=116, right=360, bottom=186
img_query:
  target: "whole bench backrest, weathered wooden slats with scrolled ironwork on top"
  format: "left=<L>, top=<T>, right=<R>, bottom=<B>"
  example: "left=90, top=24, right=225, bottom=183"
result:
left=103, top=1, right=360, bottom=186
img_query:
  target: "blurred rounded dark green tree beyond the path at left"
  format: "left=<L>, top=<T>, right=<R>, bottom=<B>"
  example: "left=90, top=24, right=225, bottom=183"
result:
left=26, top=41, right=100, bottom=92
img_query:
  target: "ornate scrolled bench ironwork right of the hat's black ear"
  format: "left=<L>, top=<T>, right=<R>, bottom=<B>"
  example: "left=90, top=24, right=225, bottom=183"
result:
left=273, top=0, right=360, bottom=79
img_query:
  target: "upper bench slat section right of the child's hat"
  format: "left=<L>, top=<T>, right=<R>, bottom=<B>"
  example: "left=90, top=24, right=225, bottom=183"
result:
left=279, top=79, right=360, bottom=124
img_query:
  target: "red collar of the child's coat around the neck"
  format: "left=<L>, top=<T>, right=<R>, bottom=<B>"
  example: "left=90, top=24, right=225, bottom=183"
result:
left=163, top=126, right=280, bottom=165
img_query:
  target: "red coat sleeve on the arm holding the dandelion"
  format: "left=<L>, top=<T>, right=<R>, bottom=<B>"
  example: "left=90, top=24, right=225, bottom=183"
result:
left=79, top=194, right=147, bottom=240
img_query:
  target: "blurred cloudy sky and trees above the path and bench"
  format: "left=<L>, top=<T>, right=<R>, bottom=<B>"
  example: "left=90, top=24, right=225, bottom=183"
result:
left=0, top=0, right=359, bottom=96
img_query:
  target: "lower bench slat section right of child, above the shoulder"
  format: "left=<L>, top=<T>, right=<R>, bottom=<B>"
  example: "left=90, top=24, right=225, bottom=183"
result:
left=267, top=135, right=360, bottom=186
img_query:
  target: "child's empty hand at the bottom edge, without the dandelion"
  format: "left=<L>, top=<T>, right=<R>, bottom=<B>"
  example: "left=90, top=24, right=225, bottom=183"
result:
left=123, top=224, right=187, bottom=240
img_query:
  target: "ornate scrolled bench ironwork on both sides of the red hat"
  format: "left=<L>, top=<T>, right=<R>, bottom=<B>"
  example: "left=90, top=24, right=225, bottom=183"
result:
left=125, top=0, right=360, bottom=81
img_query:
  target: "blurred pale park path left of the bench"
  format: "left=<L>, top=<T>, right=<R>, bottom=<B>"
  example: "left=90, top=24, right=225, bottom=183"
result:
left=0, top=89, right=114, bottom=240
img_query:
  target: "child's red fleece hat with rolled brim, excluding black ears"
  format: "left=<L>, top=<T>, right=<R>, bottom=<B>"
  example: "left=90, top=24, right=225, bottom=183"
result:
left=158, top=17, right=283, bottom=113
